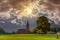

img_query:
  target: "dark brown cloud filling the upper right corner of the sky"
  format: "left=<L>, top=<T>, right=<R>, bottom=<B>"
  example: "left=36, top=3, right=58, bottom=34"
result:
left=39, top=0, right=60, bottom=11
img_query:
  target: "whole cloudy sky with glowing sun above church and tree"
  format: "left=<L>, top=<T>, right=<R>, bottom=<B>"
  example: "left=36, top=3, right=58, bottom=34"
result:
left=0, top=0, right=60, bottom=32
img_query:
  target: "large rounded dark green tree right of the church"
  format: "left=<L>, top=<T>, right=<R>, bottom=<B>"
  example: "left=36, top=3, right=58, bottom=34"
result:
left=33, top=16, right=50, bottom=33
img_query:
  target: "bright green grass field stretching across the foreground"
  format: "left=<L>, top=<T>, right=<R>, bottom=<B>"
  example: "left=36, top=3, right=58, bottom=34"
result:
left=0, top=34, right=60, bottom=40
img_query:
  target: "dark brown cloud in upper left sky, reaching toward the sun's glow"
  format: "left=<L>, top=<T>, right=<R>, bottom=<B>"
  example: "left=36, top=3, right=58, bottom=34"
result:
left=0, top=0, right=32, bottom=11
